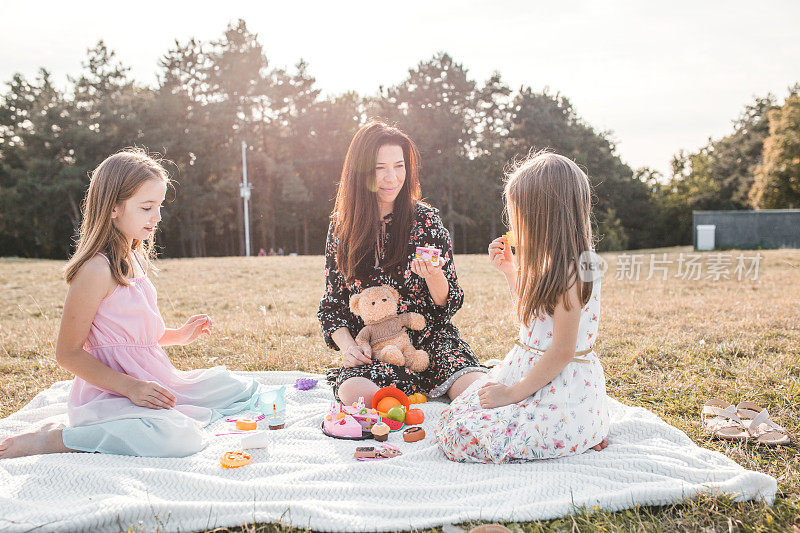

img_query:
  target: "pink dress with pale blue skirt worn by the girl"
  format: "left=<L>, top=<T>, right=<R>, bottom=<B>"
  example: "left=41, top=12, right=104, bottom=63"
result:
left=63, top=256, right=259, bottom=457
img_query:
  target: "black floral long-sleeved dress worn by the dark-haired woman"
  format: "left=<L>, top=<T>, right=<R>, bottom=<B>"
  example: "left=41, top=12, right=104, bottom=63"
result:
left=317, top=204, right=488, bottom=399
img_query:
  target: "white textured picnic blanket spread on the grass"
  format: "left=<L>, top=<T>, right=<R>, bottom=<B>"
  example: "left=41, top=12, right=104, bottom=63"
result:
left=0, top=372, right=777, bottom=532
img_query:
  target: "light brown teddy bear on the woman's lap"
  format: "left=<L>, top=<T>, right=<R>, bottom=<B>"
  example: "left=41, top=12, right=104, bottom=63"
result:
left=350, top=285, right=430, bottom=372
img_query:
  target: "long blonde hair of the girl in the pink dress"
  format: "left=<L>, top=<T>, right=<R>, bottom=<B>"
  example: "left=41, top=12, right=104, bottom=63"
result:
left=64, top=148, right=170, bottom=286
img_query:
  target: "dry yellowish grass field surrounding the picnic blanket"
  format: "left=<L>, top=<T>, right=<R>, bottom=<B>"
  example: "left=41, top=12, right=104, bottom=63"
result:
left=0, top=248, right=800, bottom=532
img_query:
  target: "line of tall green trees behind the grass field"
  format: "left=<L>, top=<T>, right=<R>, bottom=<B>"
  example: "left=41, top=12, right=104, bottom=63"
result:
left=0, top=20, right=800, bottom=258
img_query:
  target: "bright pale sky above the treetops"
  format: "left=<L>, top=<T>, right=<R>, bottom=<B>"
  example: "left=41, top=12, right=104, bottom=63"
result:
left=0, top=0, right=800, bottom=175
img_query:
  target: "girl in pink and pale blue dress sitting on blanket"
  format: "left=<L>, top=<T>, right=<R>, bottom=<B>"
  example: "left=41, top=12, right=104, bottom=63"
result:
left=0, top=150, right=259, bottom=459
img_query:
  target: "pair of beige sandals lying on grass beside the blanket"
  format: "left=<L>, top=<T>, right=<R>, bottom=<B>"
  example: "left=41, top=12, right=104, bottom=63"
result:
left=701, top=398, right=791, bottom=446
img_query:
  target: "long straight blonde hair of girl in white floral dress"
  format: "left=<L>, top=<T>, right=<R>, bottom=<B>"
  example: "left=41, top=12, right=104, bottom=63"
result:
left=505, top=151, right=593, bottom=325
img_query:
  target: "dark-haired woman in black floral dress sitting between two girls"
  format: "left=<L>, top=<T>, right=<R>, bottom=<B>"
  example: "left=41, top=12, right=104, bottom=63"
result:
left=318, top=121, right=487, bottom=405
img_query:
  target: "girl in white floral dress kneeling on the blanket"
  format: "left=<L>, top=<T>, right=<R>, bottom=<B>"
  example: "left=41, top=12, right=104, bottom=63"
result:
left=436, top=152, right=609, bottom=463
